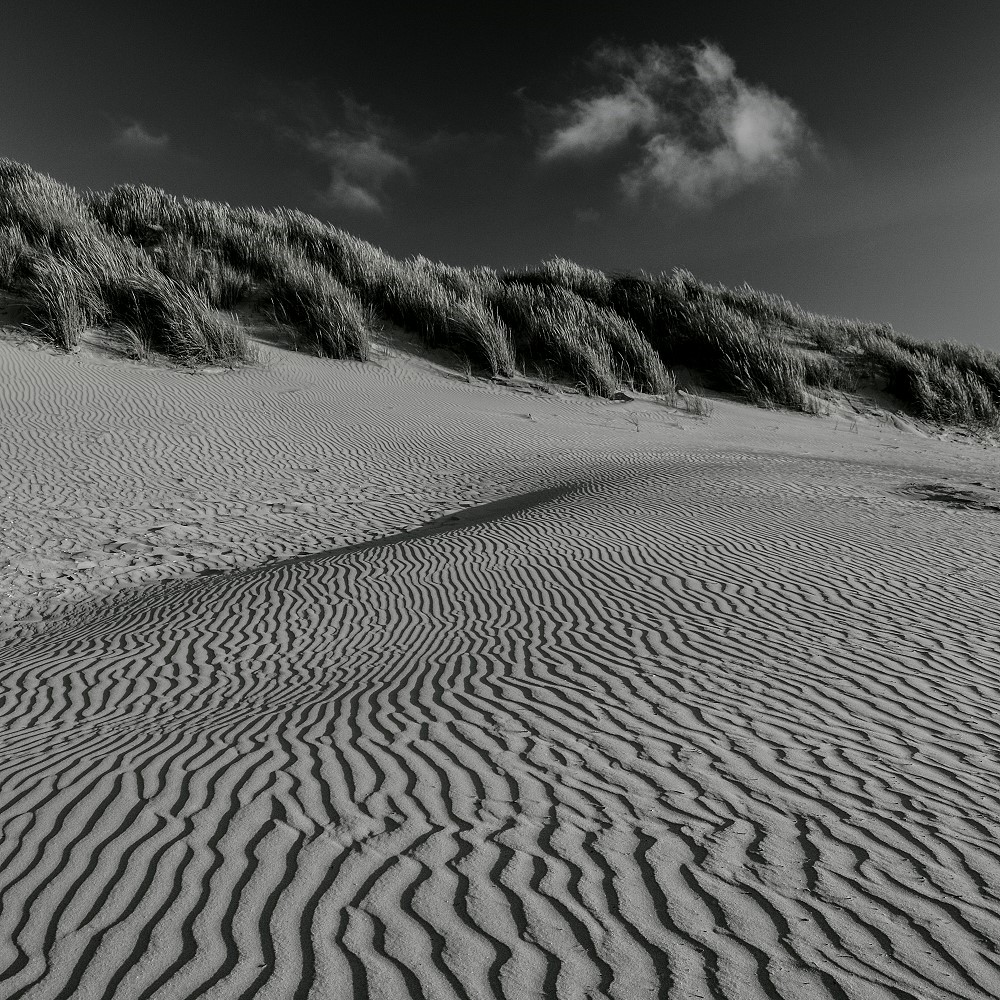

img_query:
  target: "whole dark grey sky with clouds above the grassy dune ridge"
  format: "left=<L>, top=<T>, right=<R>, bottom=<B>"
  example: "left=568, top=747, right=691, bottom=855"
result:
left=7, top=0, right=1000, bottom=348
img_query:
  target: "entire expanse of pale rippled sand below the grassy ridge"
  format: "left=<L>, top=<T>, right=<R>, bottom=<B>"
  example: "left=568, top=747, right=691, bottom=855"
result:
left=0, top=324, right=1000, bottom=1000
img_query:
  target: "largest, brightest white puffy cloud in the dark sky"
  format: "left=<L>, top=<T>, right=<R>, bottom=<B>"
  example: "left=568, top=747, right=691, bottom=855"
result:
left=539, top=42, right=818, bottom=206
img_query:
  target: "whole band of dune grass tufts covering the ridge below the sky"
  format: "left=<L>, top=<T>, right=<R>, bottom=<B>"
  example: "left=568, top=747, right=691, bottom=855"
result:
left=0, top=160, right=1000, bottom=427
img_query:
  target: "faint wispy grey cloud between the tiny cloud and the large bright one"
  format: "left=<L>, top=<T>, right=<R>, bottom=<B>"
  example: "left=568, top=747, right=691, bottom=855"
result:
left=279, top=96, right=411, bottom=212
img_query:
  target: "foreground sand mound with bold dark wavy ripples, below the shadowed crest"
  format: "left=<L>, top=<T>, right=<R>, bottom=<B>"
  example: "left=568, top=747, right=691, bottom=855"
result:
left=0, top=453, right=1000, bottom=1000
